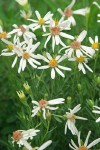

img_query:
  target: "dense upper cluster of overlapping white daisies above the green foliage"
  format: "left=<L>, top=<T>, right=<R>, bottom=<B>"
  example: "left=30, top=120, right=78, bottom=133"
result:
left=0, top=0, right=99, bottom=79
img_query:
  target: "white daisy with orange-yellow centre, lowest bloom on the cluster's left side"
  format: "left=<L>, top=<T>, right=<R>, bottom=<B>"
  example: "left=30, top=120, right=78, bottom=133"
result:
left=14, top=39, right=41, bottom=73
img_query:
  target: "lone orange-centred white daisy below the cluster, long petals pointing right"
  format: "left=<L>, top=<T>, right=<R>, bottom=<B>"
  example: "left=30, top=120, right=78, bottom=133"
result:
left=32, top=98, right=65, bottom=119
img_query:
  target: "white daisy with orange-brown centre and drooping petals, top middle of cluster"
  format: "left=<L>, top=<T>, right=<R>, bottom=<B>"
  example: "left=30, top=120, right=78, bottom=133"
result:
left=43, top=19, right=74, bottom=51
